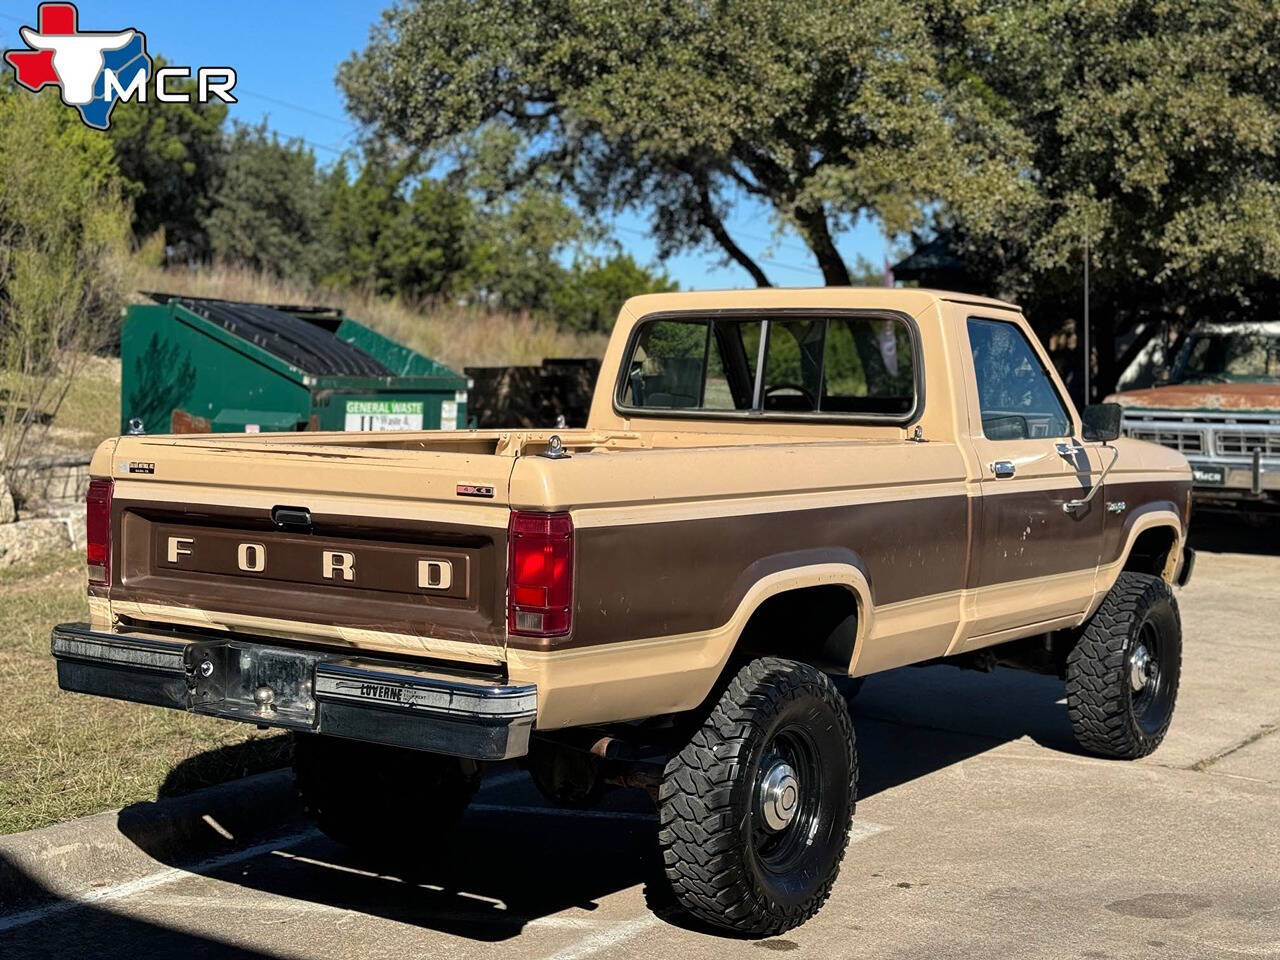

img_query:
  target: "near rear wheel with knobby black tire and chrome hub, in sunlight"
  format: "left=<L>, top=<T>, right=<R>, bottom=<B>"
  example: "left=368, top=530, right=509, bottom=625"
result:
left=658, top=658, right=858, bottom=937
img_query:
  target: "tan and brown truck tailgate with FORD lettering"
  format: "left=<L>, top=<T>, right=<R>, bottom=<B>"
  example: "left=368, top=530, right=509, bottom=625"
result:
left=95, top=434, right=513, bottom=663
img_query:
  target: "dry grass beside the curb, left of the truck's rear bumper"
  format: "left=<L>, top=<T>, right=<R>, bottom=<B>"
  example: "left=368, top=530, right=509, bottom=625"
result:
left=0, top=554, right=288, bottom=833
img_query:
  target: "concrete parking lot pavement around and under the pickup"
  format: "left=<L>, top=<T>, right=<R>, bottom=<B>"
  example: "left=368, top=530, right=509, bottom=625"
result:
left=0, top=520, right=1280, bottom=960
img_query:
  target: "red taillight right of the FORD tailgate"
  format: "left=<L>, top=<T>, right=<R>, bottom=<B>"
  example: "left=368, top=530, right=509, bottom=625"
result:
left=507, top=509, right=573, bottom=636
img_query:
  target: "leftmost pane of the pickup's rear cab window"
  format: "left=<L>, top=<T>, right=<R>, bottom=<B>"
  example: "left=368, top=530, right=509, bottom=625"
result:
left=622, top=320, right=710, bottom=410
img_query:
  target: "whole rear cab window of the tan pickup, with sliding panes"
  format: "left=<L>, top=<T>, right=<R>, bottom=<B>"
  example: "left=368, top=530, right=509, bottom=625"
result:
left=617, top=312, right=920, bottom=421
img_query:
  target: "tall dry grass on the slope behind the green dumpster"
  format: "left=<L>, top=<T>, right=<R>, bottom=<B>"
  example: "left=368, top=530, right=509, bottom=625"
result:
left=137, top=266, right=608, bottom=372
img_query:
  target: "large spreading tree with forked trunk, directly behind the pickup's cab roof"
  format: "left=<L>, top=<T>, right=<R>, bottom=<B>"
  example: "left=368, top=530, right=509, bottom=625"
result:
left=339, top=0, right=1019, bottom=284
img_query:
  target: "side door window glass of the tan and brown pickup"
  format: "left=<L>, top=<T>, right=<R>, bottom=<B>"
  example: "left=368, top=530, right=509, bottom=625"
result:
left=969, top=317, right=1071, bottom=440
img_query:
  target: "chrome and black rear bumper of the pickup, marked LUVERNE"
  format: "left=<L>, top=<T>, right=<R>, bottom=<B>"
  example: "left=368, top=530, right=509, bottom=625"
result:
left=51, top=623, right=538, bottom=760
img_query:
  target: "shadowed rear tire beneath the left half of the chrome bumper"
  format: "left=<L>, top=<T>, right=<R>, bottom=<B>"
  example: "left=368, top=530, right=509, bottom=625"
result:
left=293, top=733, right=481, bottom=858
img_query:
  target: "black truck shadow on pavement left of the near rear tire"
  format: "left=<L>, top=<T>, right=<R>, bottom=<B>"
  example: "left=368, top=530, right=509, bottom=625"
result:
left=122, top=771, right=657, bottom=941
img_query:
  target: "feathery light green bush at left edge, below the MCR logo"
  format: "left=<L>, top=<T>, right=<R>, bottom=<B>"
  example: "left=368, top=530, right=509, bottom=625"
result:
left=0, top=83, right=129, bottom=481
